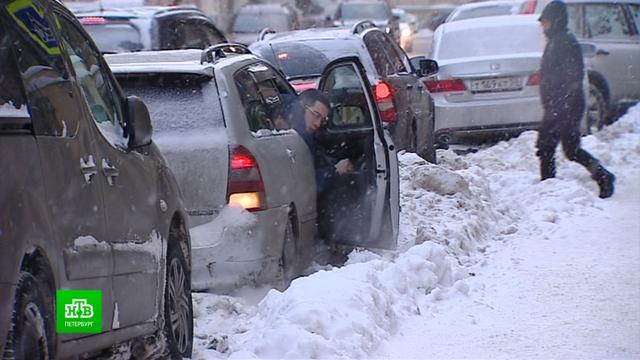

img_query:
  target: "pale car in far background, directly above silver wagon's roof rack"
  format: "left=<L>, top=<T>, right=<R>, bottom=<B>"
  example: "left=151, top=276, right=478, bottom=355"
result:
left=229, top=3, right=300, bottom=45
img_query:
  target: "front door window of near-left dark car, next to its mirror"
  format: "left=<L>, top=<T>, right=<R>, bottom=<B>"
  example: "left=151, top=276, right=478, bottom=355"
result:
left=58, top=12, right=127, bottom=149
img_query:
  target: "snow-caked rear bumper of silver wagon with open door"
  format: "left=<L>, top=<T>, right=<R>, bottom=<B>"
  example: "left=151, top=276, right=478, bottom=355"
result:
left=191, top=206, right=289, bottom=291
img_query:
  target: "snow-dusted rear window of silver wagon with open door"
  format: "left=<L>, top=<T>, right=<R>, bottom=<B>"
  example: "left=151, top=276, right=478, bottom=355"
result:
left=118, top=74, right=224, bottom=136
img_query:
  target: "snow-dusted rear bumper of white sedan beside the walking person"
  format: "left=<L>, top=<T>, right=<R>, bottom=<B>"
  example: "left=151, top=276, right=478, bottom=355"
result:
left=434, top=97, right=543, bottom=146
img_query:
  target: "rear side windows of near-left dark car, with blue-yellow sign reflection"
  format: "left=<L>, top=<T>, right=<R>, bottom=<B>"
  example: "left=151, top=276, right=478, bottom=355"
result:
left=0, top=2, right=78, bottom=137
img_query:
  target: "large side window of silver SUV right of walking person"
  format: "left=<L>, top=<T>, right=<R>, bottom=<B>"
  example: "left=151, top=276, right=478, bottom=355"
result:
left=585, top=4, right=631, bottom=39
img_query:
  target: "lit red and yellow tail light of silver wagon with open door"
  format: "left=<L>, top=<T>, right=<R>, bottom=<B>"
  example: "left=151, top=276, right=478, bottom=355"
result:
left=227, top=146, right=265, bottom=211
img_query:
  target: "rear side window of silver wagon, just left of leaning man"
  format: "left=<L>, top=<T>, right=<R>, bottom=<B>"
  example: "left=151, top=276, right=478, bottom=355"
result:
left=234, top=63, right=296, bottom=135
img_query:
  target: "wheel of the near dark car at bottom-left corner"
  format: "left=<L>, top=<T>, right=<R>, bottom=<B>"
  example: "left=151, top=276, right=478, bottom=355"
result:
left=2, top=272, right=55, bottom=359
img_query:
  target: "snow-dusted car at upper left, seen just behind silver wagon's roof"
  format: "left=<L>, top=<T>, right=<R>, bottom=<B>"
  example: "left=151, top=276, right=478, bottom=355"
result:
left=75, top=6, right=227, bottom=53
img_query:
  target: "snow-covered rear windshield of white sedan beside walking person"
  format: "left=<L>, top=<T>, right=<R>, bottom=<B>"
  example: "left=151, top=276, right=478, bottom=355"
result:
left=434, top=26, right=544, bottom=60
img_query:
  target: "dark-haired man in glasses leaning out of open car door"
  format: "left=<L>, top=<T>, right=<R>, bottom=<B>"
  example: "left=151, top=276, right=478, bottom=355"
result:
left=290, top=89, right=353, bottom=193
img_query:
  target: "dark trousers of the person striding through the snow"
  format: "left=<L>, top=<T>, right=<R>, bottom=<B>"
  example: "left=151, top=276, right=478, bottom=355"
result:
left=536, top=112, right=600, bottom=180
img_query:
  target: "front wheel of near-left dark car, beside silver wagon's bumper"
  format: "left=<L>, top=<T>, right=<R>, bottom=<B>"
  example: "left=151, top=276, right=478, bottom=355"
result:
left=164, top=246, right=193, bottom=359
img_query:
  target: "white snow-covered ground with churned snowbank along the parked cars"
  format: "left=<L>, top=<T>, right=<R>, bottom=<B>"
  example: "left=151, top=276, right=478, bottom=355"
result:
left=193, top=105, right=640, bottom=359
